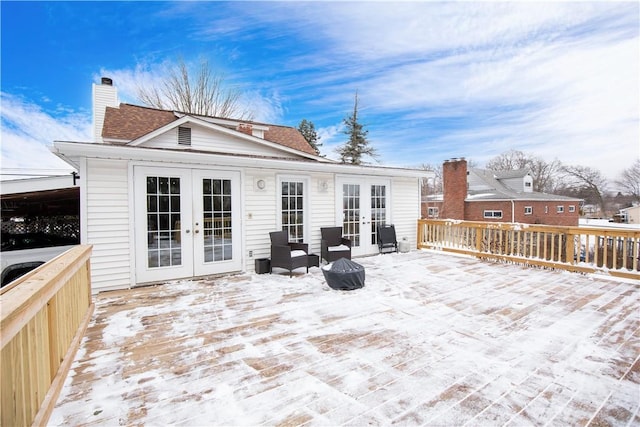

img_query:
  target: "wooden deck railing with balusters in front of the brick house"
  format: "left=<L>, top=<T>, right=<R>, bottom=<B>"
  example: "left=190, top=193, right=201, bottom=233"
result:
left=418, top=220, right=640, bottom=279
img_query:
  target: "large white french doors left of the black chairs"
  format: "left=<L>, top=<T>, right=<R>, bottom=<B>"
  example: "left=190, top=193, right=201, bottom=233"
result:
left=134, top=166, right=242, bottom=282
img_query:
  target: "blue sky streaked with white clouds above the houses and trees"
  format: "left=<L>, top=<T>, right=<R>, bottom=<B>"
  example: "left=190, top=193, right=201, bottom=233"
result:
left=0, top=1, right=640, bottom=180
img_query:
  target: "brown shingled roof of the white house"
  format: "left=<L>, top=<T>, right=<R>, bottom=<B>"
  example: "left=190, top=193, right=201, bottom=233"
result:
left=102, top=104, right=317, bottom=155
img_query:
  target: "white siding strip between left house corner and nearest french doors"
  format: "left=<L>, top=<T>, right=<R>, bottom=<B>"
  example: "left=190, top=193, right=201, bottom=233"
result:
left=85, top=159, right=133, bottom=293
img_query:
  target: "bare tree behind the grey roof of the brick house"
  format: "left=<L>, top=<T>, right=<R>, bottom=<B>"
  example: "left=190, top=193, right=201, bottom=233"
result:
left=486, top=150, right=561, bottom=193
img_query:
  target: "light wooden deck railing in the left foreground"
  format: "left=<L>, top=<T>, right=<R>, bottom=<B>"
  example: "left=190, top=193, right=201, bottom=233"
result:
left=0, top=245, right=93, bottom=426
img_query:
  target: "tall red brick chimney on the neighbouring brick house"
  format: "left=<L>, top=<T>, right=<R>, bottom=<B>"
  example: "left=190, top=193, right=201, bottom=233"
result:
left=440, top=158, right=467, bottom=220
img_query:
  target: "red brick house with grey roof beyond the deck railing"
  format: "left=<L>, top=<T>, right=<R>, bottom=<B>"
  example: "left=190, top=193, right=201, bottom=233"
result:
left=422, top=159, right=580, bottom=226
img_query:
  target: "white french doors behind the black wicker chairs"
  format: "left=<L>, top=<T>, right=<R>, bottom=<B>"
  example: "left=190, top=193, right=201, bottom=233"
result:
left=336, top=178, right=390, bottom=256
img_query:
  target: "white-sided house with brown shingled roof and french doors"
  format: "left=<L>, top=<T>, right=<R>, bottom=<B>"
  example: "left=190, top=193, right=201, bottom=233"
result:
left=53, top=78, right=432, bottom=292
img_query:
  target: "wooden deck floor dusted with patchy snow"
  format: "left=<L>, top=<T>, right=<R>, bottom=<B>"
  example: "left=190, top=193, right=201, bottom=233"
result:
left=50, top=251, right=640, bottom=426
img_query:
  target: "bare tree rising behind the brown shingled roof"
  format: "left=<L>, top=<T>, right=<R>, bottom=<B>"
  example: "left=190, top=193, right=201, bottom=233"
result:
left=138, top=59, right=253, bottom=120
